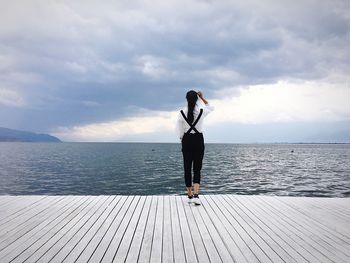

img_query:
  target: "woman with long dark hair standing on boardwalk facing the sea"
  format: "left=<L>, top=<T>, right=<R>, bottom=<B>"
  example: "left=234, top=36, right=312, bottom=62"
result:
left=177, top=90, right=213, bottom=205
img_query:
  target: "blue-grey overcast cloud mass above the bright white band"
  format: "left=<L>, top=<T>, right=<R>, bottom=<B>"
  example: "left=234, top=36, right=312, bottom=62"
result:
left=0, top=0, right=350, bottom=134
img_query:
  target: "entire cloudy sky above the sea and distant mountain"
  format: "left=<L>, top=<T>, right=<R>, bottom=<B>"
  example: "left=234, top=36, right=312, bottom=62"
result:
left=0, top=0, right=350, bottom=143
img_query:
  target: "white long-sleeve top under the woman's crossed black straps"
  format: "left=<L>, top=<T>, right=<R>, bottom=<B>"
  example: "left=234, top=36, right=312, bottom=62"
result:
left=176, top=103, right=214, bottom=140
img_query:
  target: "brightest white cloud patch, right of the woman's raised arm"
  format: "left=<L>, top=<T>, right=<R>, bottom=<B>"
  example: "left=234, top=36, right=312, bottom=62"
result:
left=209, top=80, right=350, bottom=125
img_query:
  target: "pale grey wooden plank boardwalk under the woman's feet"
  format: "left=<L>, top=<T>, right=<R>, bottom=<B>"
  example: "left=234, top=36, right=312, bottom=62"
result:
left=0, top=195, right=350, bottom=263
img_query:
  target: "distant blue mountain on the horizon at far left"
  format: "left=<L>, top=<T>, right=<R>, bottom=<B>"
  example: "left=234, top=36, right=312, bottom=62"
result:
left=0, top=127, right=61, bottom=142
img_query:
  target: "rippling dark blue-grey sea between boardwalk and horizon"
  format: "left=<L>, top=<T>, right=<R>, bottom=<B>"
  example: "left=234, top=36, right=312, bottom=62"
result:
left=0, top=142, right=350, bottom=197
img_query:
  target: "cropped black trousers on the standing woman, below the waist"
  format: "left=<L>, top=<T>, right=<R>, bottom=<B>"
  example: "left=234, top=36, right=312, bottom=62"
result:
left=182, top=133, right=204, bottom=187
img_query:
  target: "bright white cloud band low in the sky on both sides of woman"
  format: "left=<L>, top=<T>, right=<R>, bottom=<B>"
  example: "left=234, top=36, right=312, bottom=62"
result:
left=53, top=78, right=350, bottom=141
